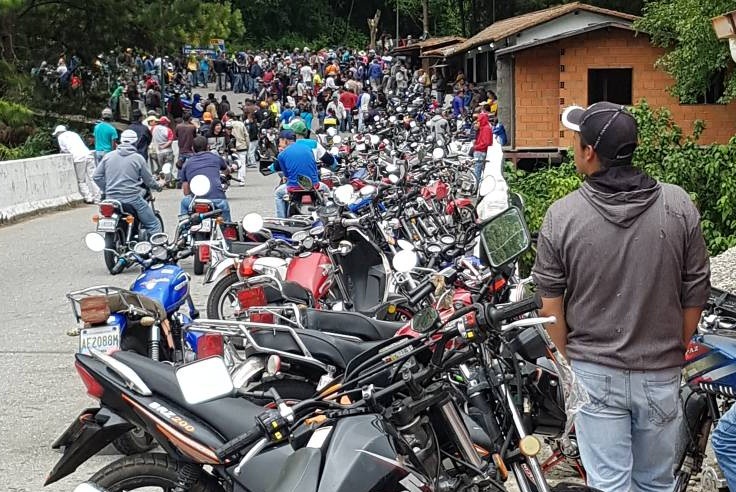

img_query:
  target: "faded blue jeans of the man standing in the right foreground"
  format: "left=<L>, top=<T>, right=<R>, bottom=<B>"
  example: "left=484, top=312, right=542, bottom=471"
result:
left=571, top=360, right=682, bottom=492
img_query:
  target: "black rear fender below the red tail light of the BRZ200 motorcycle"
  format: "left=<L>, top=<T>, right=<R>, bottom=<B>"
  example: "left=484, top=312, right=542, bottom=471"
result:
left=44, top=407, right=134, bottom=486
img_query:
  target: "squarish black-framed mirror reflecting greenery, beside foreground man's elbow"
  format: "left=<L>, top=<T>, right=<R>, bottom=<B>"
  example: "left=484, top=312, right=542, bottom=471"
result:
left=480, top=207, right=531, bottom=268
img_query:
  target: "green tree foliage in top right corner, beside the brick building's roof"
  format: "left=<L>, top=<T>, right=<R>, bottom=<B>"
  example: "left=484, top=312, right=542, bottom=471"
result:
left=635, top=0, right=736, bottom=104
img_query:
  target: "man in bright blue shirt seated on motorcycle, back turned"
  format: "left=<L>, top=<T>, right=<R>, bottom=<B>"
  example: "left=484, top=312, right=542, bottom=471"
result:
left=271, top=120, right=335, bottom=218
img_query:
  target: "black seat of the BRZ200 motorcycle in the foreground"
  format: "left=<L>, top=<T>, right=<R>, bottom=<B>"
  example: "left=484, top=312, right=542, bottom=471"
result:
left=112, top=350, right=264, bottom=440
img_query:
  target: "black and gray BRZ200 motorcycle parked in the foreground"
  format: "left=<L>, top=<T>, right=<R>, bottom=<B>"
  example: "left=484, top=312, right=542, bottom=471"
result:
left=46, top=210, right=588, bottom=492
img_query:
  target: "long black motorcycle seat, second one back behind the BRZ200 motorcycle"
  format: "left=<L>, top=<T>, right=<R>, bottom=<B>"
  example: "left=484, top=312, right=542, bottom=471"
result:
left=302, top=309, right=404, bottom=341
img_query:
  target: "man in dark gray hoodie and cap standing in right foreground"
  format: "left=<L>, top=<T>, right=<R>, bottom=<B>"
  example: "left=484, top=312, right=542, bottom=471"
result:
left=532, top=102, right=710, bottom=492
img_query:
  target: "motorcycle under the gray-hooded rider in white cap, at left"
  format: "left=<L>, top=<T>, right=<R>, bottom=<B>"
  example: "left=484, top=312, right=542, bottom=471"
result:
left=92, top=189, right=164, bottom=275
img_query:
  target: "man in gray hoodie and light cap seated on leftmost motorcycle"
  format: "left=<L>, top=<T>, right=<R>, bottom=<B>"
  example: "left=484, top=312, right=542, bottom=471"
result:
left=92, top=130, right=162, bottom=234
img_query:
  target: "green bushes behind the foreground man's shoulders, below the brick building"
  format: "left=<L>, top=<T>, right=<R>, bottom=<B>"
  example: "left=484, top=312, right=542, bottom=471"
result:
left=506, top=101, right=736, bottom=255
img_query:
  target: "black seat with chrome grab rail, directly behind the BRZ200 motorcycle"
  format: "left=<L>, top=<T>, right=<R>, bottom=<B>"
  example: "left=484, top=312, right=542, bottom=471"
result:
left=251, top=330, right=385, bottom=371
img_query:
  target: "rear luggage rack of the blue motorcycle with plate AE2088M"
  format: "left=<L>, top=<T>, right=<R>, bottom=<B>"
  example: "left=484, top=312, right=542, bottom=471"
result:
left=66, top=285, right=166, bottom=325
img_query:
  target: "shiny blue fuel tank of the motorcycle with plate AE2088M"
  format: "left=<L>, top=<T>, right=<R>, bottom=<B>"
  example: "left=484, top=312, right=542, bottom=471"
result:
left=130, top=265, right=189, bottom=313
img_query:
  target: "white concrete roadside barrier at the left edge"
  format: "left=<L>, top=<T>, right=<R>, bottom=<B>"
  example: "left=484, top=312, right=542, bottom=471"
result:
left=0, top=154, right=82, bottom=223
